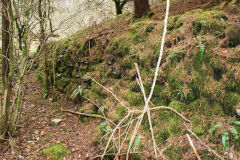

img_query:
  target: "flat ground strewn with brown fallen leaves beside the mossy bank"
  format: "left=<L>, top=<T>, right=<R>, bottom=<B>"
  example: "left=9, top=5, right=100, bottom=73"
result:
left=0, top=73, right=99, bottom=160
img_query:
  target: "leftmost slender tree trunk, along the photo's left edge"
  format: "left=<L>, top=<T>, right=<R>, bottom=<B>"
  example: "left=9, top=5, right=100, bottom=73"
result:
left=0, top=0, right=11, bottom=138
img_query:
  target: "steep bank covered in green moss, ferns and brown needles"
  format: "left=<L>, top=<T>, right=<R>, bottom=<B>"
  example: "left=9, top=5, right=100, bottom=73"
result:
left=38, top=1, right=240, bottom=159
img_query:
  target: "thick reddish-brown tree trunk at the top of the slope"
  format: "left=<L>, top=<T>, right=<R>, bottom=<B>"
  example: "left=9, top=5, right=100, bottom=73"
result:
left=134, top=0, right=150, bottom=18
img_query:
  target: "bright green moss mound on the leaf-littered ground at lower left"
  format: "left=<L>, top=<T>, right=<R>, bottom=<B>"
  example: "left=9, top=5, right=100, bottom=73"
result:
left=43, top=143, right=69, bottom=160
